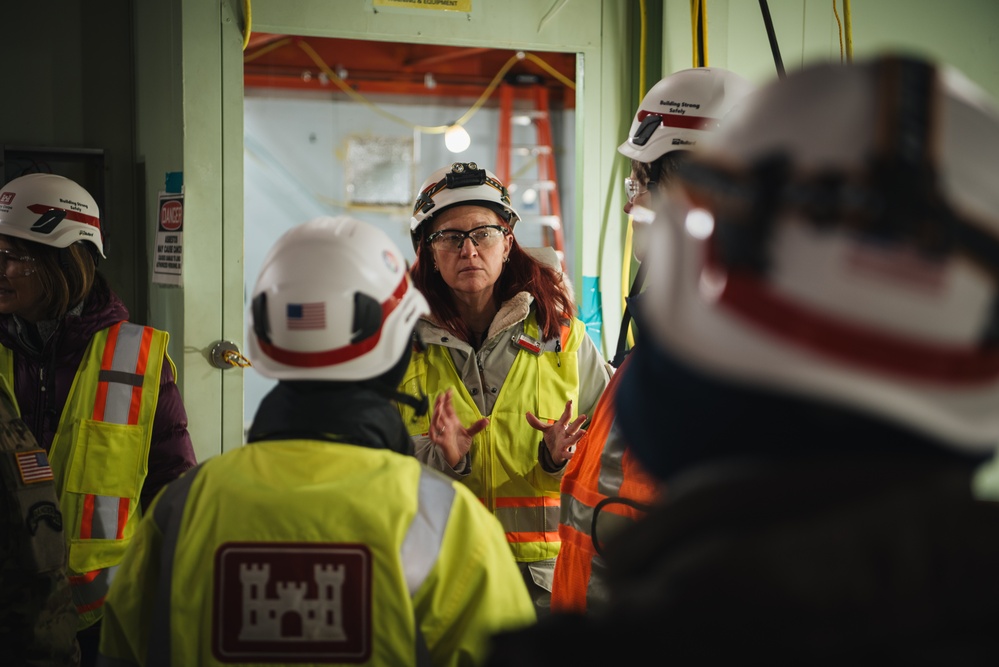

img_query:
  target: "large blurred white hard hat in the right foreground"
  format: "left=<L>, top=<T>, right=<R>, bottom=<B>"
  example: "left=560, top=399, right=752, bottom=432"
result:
left=638, top=56, right=999, bottom=455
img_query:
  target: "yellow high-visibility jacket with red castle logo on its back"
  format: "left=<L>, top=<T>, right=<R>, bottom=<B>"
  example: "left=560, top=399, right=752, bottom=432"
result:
left=101, top=440, right=536, bottom=667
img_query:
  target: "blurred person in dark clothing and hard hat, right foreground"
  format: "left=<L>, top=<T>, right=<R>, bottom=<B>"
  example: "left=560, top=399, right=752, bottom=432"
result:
left=489, top=54, right=999, bottom=666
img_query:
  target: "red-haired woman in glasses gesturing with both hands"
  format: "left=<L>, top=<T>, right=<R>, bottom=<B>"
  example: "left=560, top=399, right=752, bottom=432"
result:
left=400, top=162, right=610, bottom=614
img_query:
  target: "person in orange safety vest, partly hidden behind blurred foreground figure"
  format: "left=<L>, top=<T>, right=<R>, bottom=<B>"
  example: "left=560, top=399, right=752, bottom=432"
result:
left=552, top=67, right=753, bottom=612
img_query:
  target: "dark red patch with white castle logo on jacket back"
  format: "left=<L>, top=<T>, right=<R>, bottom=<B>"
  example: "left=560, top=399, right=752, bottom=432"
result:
left=212, top=542, right=371, bottom=663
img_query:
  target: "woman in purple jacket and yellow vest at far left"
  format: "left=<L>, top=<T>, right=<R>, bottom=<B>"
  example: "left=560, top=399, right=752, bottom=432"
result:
left=0, top=174, right=196, bottom=667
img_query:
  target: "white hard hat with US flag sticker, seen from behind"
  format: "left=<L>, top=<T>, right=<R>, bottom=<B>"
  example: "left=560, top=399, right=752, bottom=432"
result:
left=247, top=217, right=430, bottom=381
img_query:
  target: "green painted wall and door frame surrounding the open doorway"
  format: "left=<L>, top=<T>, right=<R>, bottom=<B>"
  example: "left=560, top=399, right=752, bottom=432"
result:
left=0, top=0, right=999, bottom=458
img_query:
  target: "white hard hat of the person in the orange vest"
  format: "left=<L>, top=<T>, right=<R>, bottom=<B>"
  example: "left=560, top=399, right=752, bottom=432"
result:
left=617, top=67, right=753, bottom=162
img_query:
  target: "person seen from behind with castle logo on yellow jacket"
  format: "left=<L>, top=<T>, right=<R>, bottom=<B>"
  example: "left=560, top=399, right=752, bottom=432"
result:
left=101, top=217, right=536, bottom=666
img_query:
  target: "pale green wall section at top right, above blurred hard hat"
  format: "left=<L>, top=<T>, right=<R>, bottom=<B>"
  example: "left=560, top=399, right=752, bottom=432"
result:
left=663, top=0, right=999, bottom=99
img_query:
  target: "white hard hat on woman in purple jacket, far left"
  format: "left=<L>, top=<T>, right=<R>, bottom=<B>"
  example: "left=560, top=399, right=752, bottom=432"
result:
left=0, top=174, right=104, bottom=257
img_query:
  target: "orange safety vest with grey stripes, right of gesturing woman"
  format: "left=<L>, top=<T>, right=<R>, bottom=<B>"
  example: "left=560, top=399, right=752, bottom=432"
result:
left=552, top=357, right=661, bottom=612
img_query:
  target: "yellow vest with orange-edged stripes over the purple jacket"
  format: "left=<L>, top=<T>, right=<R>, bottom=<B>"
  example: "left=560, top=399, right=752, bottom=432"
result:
left=0, top=322, right=172, bottom=629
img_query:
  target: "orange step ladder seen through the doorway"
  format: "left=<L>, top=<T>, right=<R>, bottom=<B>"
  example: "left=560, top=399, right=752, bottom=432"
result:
left=496, top=82, right=565, bottom=270
